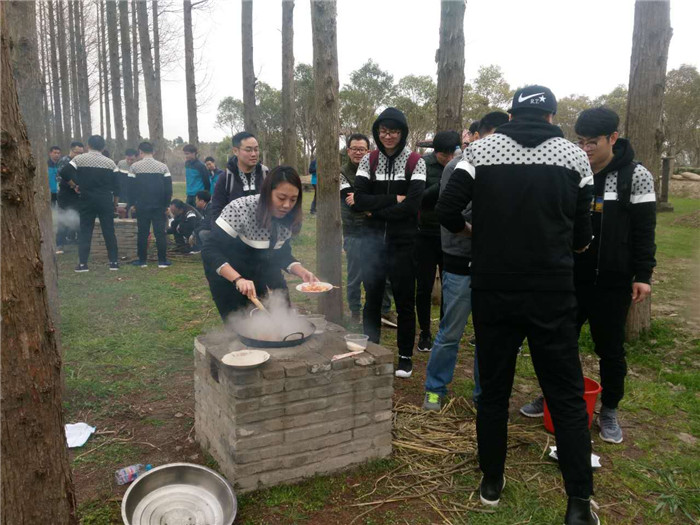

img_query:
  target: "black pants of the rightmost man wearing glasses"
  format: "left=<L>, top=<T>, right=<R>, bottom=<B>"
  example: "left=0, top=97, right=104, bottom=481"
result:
left=576, top=283, right=632, bottom=408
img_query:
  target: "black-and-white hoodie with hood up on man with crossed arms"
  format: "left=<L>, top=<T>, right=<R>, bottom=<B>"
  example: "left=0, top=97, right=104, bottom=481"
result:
left=352, top=108, right=426, bottom=244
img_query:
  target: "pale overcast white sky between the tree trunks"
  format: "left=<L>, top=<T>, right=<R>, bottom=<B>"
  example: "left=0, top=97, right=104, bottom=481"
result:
left=156, top=0, right=700, bottom=142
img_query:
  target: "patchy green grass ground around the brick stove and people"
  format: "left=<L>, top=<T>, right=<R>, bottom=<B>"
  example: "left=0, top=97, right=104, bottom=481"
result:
left=59, top=185, right=700, bottom=525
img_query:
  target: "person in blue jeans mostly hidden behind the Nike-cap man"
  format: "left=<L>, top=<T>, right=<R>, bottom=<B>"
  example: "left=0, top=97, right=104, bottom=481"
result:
left=423, top=111, right=508, bottom=411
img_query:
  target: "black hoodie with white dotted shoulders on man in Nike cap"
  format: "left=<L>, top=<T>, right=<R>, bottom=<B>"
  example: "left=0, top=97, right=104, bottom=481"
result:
left=435, top=118, right=593, bottom=291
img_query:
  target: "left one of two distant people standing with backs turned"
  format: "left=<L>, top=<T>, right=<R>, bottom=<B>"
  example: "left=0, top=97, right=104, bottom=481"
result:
left=61, top=135, right=119, bottom=273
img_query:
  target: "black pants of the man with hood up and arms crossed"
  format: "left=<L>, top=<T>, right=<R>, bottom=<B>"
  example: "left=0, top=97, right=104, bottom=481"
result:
left=362, top=237, right=416, bottom=357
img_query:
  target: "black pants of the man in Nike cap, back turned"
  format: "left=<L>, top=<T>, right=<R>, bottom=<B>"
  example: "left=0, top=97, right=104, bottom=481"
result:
left=472, top=289, right=593, bottom=498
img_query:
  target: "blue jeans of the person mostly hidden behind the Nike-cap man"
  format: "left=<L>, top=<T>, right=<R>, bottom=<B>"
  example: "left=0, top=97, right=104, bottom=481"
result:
left=425, top=272, right=478, bottom=396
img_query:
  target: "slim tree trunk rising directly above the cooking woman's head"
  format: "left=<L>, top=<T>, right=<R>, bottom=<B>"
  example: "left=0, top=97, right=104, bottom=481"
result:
left=282, top=0, right=297, bottom=168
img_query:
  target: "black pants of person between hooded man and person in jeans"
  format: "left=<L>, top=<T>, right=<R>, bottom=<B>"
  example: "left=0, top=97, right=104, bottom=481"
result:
left=415, top=235, right=443, bottom=334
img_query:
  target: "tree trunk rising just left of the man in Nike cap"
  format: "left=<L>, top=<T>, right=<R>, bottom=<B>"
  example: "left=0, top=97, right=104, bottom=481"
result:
left=435, top=0, right=466, bottom=133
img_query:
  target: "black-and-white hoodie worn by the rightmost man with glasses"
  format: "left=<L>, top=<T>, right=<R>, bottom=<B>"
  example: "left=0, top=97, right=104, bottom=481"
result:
left=574, top=139, right=656, bottom=288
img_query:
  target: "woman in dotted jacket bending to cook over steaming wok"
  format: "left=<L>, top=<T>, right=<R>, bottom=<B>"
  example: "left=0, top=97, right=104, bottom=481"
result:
left=202, top=166, right=317, bottom=320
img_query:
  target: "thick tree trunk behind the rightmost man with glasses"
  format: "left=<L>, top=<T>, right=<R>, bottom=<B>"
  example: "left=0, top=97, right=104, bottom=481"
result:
left=625, top=0, right=672, bottom=339
